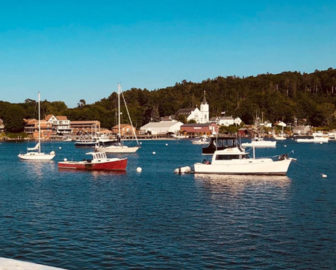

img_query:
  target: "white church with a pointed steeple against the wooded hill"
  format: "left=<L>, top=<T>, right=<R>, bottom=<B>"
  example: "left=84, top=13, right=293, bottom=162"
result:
left=176, top=91, right=209, bottom=124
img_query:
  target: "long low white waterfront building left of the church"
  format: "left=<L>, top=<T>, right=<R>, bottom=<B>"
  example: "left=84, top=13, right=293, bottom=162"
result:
left=140, top=120, right=183, bottom=135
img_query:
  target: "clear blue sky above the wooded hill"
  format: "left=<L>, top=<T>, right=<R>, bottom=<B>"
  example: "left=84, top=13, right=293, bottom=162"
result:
left=0, top=0, right=336, bottom=107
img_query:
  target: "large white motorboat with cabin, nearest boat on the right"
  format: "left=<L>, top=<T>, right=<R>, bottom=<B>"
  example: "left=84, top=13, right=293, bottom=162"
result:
left=194, top=146, right=293, bottom=175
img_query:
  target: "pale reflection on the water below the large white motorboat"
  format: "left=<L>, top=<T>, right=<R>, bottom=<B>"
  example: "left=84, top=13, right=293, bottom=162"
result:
left=194, top=174, right=291, bottom=195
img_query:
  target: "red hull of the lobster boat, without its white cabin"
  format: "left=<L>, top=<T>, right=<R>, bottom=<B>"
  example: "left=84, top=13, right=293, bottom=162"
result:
left=58, top=158, right=127, bottom=171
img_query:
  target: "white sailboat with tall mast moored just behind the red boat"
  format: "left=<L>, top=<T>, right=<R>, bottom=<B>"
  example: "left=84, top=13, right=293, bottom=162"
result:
left=95, top=84, right=140, bottom=154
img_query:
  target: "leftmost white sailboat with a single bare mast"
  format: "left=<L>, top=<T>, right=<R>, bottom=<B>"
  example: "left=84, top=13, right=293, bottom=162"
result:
left=18, top=92, right=55, bottom=161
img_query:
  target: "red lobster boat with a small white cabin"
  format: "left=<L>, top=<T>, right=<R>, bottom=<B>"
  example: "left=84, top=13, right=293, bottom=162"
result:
left=58, top=152, right=127, bottom=171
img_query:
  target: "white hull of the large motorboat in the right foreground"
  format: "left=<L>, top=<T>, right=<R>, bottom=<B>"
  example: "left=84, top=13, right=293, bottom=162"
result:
left=194, top=158, right=292, bottom=175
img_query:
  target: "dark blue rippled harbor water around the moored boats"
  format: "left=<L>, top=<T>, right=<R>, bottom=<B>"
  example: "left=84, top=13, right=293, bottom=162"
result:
left=0, top=140, right=336, bottom=269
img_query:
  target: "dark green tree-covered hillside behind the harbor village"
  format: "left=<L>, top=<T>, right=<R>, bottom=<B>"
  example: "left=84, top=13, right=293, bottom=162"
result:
left=0, top=68, right=336, bottom=132
